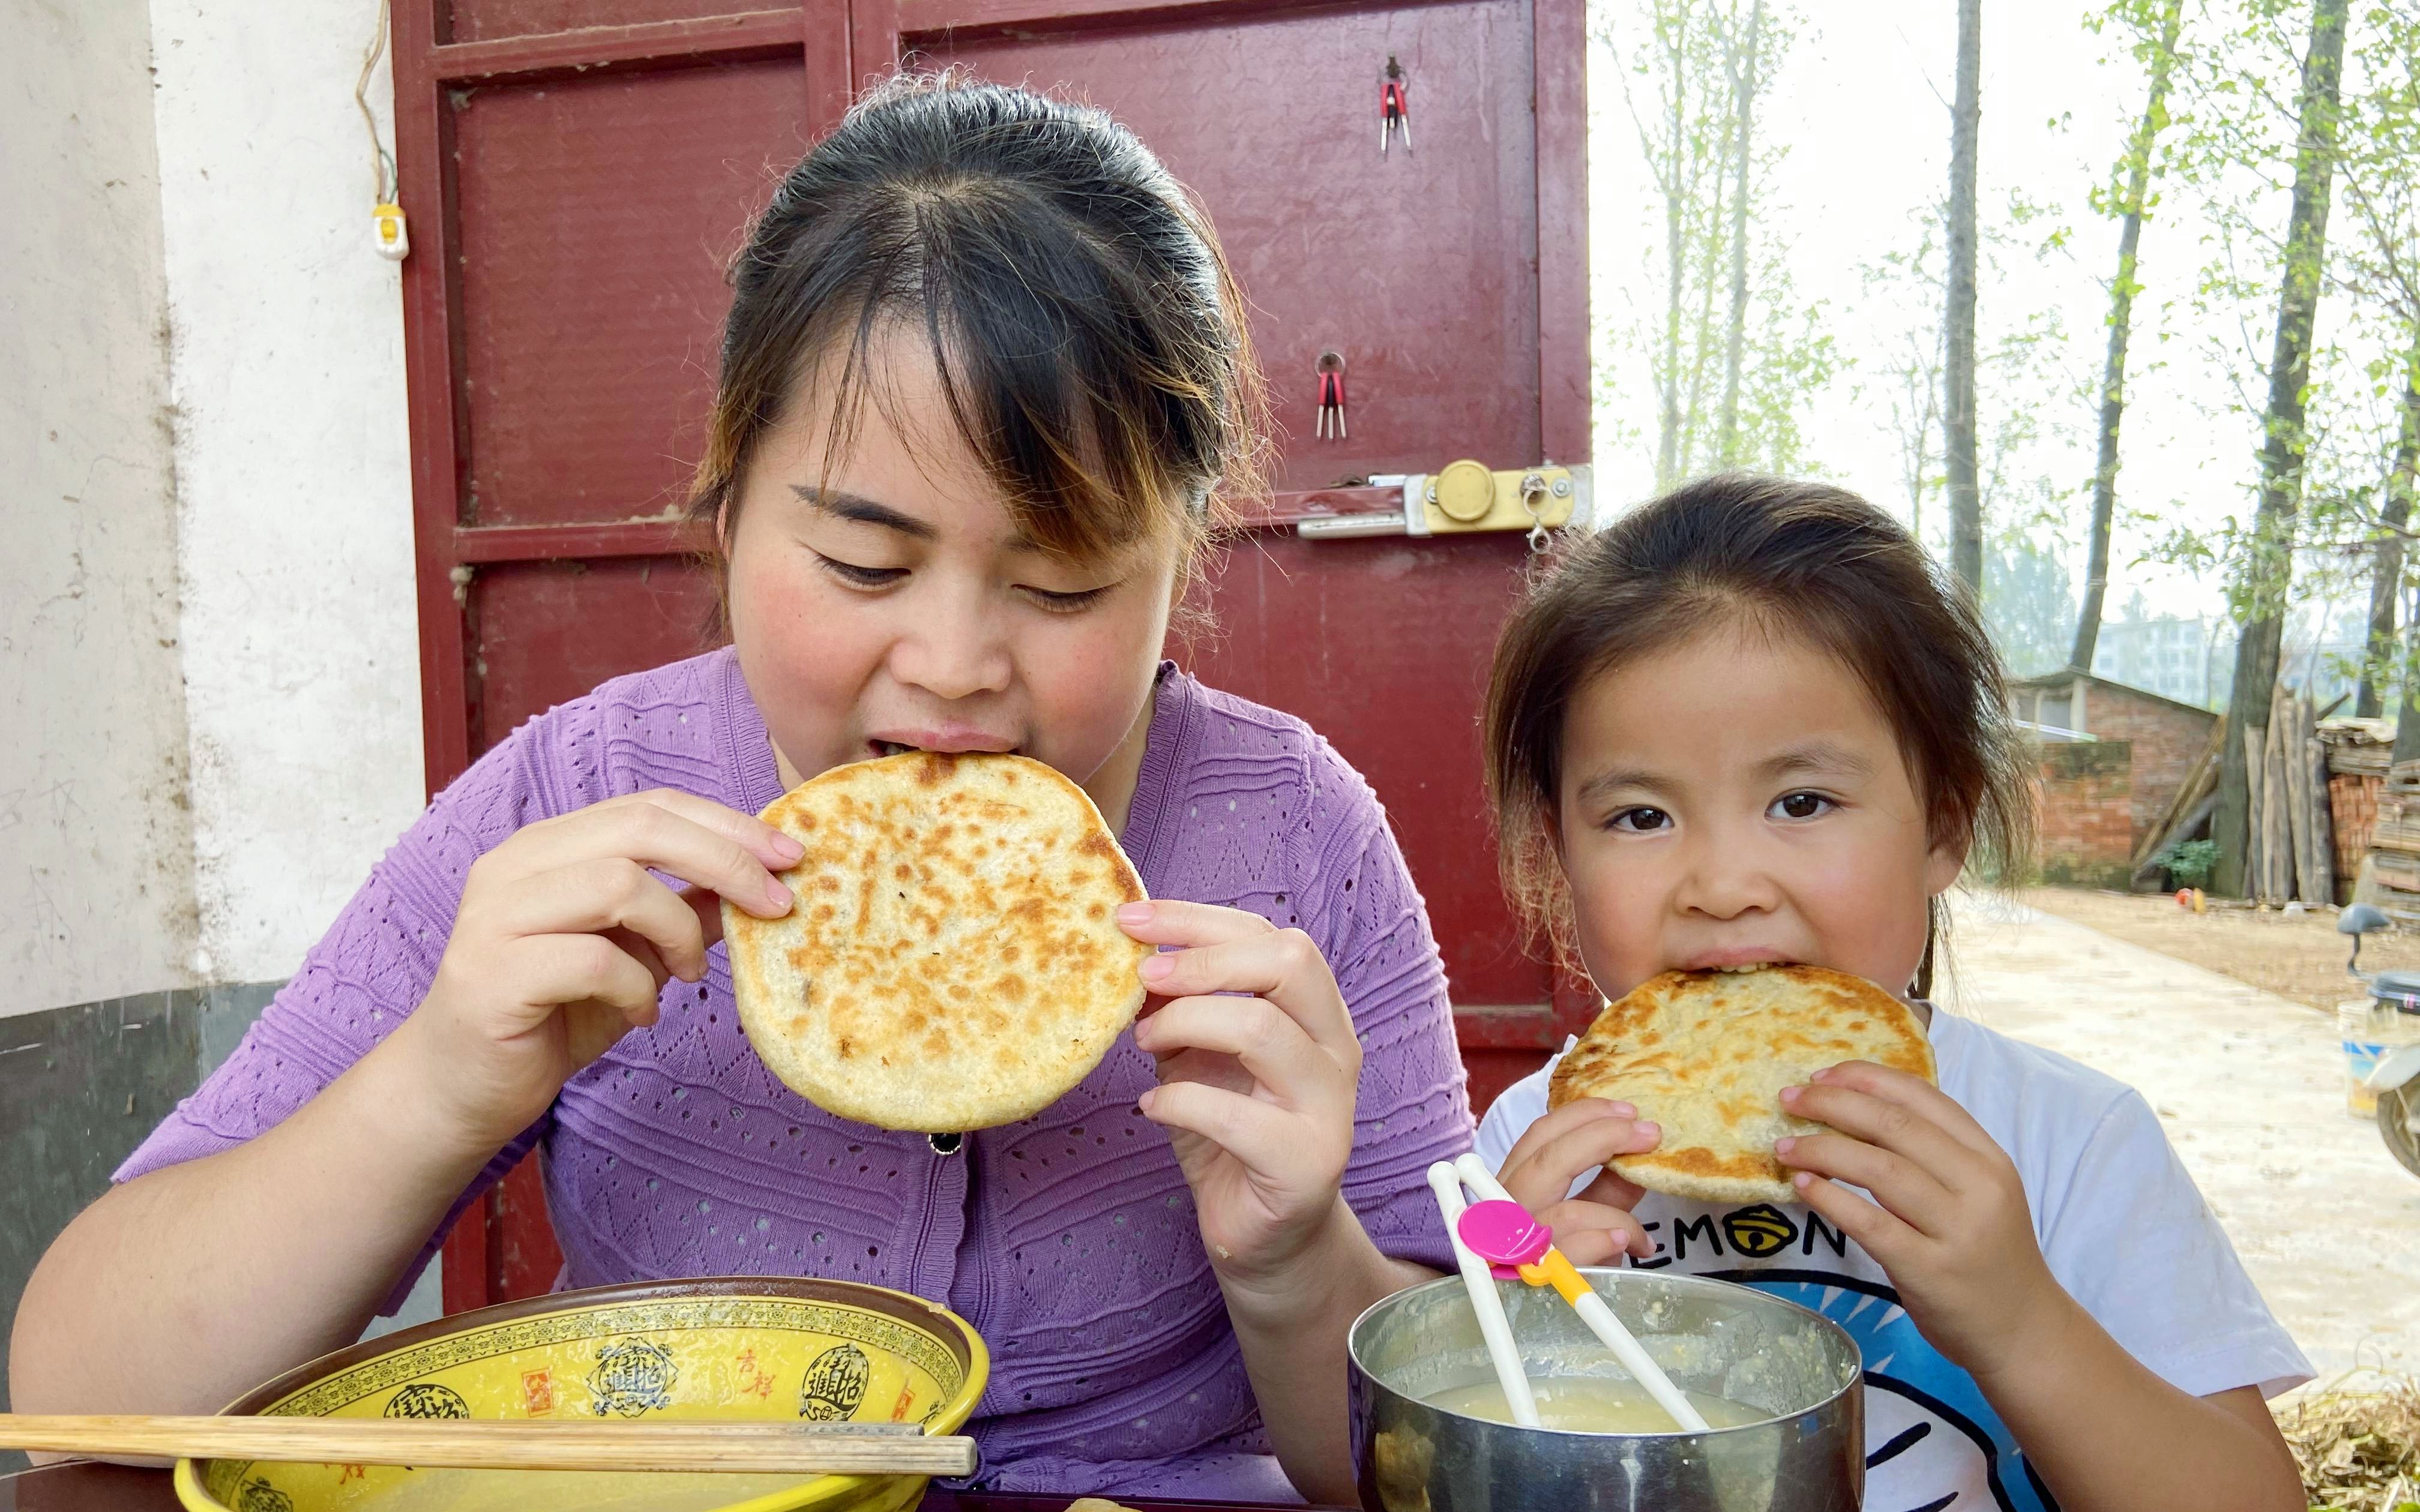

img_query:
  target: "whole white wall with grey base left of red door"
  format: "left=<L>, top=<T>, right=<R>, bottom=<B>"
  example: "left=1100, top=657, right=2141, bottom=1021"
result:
left=0, top=0, right=436, bottom=1442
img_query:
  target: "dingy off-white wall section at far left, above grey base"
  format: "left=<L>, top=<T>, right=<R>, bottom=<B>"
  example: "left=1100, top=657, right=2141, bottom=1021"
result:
left=0, top=0, right=194, bottom=1016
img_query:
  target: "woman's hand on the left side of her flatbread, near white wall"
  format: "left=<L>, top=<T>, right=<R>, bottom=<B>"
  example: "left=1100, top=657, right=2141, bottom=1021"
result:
left=394, top=788, right=804, bottom=1149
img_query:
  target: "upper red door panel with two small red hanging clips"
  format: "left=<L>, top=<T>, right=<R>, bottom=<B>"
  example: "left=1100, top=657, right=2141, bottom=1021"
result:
left=912, top=0, right=1539, bottom=491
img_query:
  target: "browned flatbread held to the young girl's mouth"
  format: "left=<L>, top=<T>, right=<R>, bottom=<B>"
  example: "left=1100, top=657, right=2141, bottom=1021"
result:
left=1546, top=965, right=1936, bottom=1202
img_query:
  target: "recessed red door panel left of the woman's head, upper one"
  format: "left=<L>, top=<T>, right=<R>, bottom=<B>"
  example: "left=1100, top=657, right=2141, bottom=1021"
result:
left=453, top=58, right=806, bottom=530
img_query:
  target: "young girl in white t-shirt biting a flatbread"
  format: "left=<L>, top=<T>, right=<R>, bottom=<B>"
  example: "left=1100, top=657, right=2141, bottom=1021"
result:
left=1479, top=476, right=2311, bottom=1512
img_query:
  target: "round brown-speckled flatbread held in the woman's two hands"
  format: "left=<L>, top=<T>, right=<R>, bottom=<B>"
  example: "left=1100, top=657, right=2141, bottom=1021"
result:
left=724, top=750, right=1152, bottom=1135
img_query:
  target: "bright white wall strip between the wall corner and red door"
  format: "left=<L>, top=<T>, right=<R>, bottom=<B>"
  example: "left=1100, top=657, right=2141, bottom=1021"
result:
left=150, top=0, right=421, bottom=982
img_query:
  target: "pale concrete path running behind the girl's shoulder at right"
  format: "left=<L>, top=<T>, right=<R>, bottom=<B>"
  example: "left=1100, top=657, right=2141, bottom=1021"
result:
left=1939, top=900, right=2420, bottom=1374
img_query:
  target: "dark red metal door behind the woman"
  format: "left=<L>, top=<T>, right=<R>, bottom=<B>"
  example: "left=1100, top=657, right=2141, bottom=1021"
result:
left=394, top=0, right=1590, bottom=1311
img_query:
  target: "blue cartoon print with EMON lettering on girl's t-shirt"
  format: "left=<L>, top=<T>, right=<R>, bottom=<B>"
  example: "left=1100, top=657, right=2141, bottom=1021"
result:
left=1634, top=1202, right=2057, bottom=1512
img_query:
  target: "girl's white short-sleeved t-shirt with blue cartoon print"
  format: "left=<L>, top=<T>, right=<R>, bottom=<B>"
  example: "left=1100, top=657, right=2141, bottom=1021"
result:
left=1479, top=1009, right=2311, bottom=1512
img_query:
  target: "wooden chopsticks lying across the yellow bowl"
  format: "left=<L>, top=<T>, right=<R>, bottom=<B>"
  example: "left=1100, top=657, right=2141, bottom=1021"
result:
left=0, top=1413, right=975, bottom=1476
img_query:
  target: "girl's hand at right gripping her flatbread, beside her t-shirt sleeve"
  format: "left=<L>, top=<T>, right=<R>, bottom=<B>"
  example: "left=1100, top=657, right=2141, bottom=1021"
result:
left=1774, top=1060, right=2074, bottom=1376
